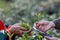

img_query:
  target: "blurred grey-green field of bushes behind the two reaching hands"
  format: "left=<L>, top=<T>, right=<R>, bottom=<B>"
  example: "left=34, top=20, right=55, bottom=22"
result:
left=0, top=0, right=60, bottom=37
